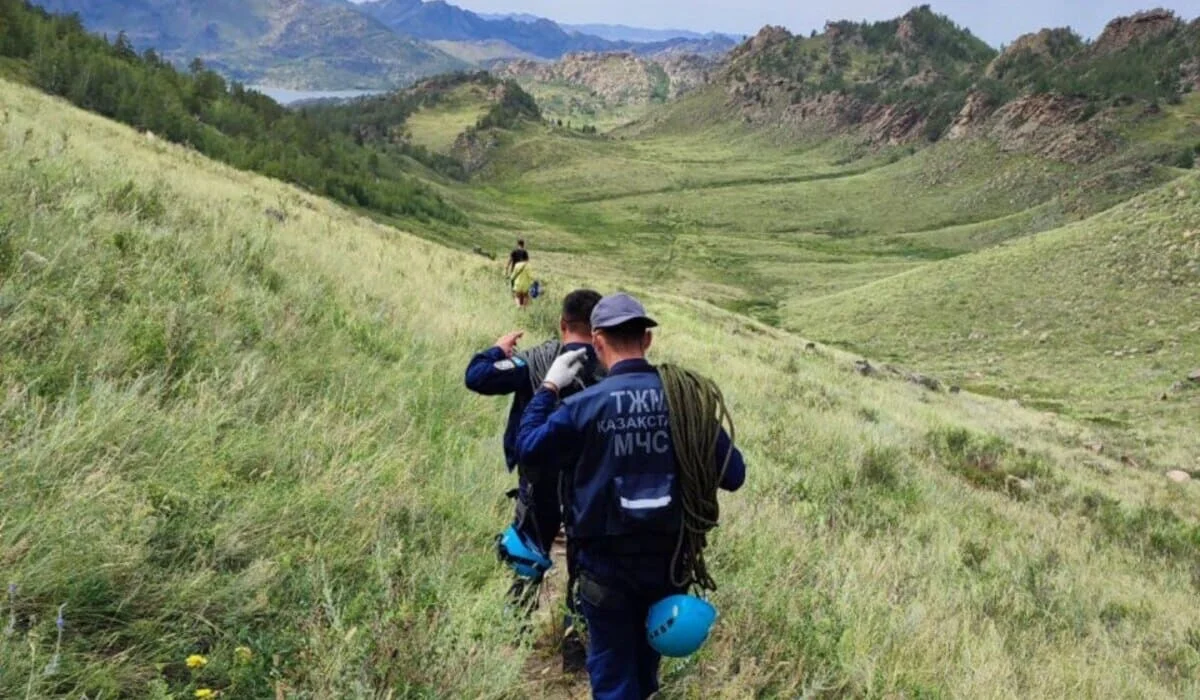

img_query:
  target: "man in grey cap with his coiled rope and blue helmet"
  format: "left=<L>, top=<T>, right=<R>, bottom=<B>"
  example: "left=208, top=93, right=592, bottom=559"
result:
left=517, top=294, right=745, bottom=700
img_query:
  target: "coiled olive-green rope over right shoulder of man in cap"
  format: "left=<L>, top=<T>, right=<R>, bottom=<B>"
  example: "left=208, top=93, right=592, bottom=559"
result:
left=659, top=365, right=734, bottom=591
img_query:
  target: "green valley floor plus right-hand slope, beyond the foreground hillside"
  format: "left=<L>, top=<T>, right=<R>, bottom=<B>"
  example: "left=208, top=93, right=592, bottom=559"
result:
left=465, top=68, right=1200, bottom=456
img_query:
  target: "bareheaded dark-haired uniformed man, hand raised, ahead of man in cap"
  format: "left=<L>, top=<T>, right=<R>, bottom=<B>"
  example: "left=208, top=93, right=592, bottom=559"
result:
left=466, top=289, right=604, bottom=670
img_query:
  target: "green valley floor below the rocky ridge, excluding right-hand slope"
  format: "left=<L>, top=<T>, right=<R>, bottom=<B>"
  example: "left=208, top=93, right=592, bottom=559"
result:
left=485, top=102, right=1180, bottom=323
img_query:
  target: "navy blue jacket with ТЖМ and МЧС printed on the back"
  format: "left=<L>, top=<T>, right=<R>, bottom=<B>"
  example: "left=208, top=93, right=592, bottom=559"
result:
left=517, top=360, right=745, bottom=588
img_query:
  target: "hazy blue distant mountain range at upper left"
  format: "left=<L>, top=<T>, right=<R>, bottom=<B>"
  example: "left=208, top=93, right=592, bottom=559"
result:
left=34, top=0, right=736, bottom=90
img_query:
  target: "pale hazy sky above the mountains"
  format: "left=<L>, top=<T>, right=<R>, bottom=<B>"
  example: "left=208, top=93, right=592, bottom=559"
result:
left=400, top=0, right=1200, bottom=46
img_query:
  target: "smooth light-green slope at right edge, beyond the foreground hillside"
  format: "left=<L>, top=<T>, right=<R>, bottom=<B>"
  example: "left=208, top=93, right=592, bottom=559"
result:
left=784, top=175, right=1200, bottom=454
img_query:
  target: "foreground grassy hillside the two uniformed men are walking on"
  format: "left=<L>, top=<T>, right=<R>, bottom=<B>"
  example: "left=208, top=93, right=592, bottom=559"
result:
left=0, top=76, right=1200, bottom=698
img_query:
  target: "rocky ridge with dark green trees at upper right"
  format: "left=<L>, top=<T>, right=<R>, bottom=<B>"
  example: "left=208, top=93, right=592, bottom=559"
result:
left=714, top=6, right=1200, bottom=162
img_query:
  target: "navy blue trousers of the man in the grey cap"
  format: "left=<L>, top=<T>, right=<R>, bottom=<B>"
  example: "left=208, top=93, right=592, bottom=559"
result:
left=580, top=600, right=662, bottom=700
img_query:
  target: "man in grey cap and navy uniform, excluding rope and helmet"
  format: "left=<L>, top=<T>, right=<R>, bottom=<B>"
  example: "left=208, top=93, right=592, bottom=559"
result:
left=517, top=294, right=745, bottom=700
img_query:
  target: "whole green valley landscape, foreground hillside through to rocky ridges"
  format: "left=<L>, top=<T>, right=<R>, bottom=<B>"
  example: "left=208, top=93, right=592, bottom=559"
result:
left=0, top=0, right=1200, bottom=699
